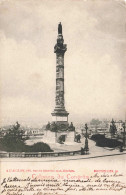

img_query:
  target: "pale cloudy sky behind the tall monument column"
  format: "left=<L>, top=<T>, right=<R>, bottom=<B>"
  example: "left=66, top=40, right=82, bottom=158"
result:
left=0, top=0, right=126, bottom=126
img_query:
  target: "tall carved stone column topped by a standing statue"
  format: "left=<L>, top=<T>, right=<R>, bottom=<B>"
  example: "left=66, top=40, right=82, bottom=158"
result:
left=52, top=23, right=69, bottom=122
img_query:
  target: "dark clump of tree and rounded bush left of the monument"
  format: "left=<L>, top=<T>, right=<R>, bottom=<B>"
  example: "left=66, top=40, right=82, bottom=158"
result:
left=0, top=122, right=53, bottom=152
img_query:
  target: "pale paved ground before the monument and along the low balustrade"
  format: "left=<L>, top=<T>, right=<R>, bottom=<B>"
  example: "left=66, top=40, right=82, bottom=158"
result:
left=1, top=139, right=126, bottom=162
